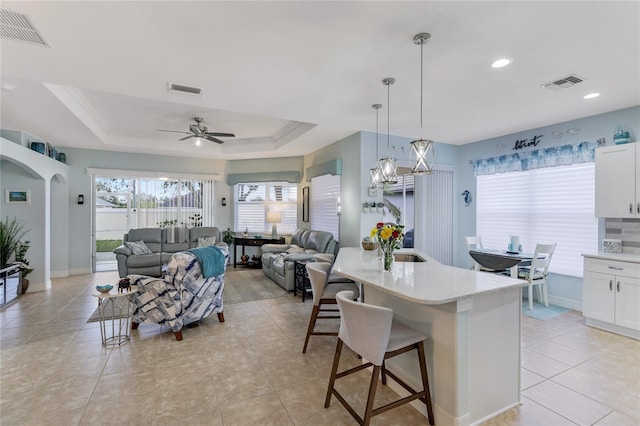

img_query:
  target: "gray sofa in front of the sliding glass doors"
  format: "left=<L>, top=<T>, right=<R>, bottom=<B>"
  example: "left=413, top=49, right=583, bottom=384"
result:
left=113, top=226, right=227, bottom=278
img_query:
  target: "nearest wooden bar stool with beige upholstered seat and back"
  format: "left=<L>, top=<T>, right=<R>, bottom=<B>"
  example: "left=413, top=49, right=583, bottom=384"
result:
left=324, top=291, right=434, bottom=425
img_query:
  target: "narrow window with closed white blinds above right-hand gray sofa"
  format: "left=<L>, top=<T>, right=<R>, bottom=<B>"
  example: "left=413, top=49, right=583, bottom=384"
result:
left=309, top=175, right=340, bottom=241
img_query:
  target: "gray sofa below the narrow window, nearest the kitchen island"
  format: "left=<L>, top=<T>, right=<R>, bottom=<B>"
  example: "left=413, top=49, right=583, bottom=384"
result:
left=261, top=229, right=338, bottom=291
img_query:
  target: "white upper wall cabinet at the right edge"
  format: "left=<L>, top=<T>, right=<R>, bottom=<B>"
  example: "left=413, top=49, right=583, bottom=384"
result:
left=596, top=143, right=640, bottom=218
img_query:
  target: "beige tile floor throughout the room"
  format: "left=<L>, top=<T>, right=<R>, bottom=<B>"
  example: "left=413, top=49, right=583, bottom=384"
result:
left=0, top=271, right=640, bottom=426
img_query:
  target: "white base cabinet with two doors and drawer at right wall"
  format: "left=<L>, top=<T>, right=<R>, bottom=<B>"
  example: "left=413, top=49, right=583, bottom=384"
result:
left=582, top=257, right=640, bottom=338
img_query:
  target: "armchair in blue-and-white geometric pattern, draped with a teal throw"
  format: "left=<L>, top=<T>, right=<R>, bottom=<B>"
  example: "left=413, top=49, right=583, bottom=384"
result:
left=129, top=246, right=229, bottom=341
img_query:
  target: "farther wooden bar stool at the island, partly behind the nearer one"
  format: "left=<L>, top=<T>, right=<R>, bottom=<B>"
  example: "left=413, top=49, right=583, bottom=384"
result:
left=302, top=262, right=360, bottom=354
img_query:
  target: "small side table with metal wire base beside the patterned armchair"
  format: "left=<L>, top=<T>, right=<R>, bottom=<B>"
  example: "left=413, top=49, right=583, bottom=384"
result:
left=92, top=286, right=138, bottom=347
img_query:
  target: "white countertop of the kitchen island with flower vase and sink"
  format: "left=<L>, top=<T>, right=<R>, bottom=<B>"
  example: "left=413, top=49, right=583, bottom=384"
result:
left=332, top=247, right=527, bottom=305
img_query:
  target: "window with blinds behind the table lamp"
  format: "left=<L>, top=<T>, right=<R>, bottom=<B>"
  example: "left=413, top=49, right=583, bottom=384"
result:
left=234, top=182, right=298, bottom=235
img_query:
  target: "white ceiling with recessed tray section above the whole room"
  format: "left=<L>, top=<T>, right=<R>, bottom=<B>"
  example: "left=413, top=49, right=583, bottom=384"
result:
left=0, top=0, right=640, bottom=159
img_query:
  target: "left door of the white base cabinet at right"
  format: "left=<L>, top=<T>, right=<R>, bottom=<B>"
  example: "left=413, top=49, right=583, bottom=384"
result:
left=582, top=272, right=615, bottom=323
